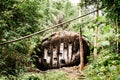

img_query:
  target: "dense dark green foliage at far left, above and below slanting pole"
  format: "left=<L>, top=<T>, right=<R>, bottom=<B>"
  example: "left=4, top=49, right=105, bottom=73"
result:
left=0, top=0, right=40, bottom=76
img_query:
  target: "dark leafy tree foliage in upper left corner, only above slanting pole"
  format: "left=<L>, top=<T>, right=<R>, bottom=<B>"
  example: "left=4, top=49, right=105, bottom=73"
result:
left=0, top=0, right=39, bottom=36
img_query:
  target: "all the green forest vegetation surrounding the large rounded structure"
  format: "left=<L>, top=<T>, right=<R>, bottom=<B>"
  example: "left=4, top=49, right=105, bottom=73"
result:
left=0, top=0, right=120, bottom=80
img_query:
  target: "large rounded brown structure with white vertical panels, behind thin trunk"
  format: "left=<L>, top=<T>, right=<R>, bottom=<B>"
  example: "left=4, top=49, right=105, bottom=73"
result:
left=32, top=31, right=90, bottom=70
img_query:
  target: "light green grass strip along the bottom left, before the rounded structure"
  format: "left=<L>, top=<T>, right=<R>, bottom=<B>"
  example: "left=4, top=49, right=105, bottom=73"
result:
left=0, top=70, right=70, bottom=80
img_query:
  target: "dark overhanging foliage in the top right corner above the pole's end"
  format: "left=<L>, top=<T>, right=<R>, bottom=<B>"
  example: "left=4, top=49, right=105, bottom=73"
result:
left=82, top=0, right=120, bottom=25
